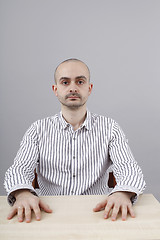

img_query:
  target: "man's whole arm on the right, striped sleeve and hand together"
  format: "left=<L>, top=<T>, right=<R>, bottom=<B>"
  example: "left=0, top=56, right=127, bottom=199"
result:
left=93, top=122, right=145, bottom=220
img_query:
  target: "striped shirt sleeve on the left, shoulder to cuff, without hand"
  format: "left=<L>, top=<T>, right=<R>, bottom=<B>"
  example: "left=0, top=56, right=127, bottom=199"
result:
left=4, top=124, right=39, bottom=205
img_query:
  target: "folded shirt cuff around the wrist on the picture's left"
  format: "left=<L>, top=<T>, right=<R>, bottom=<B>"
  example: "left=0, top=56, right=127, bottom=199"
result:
left=7, top=184, right=38, bottom=206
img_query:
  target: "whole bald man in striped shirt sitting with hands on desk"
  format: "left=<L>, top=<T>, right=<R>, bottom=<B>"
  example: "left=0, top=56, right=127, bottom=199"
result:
left=4, top=59, right=145, bottom=222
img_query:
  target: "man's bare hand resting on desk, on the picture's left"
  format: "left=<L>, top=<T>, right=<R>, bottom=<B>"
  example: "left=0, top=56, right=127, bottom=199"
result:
left=7, top=189, right=52, bottom=223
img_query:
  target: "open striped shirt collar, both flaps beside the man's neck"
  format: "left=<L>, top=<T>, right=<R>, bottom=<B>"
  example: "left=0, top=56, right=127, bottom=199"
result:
left=59, top=109, right=92, bottom=130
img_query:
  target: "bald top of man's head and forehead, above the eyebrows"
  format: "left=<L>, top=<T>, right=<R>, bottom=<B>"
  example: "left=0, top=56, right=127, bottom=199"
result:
left=54, top=58, right=90, bottom=83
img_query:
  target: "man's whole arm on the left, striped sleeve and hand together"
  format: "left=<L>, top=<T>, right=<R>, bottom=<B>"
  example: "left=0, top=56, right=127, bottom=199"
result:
left=4, top=123, right=51, bottom=222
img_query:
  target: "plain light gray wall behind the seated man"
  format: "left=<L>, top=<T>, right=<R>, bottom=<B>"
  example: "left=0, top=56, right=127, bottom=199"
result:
left=0, top=0, right=160, bottom=200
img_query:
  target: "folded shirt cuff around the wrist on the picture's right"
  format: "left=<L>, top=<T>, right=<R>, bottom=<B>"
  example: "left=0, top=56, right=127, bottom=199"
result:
left=109, top=185, right=139, bottom=204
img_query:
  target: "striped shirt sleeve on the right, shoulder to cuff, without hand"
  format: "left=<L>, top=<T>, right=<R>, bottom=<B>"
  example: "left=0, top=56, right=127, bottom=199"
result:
left=109, top=122, right=146, bottom=203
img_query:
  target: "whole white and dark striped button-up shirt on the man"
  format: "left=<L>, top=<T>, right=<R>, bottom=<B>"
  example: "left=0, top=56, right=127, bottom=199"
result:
left=4, top=111, right=145, bottom=205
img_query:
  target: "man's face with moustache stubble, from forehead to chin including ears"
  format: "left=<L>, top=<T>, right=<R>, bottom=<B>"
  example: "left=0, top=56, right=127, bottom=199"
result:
left=53, top=61, right=93, bottom=109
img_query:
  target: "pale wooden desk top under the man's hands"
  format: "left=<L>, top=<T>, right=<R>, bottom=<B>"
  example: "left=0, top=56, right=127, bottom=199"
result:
left=0, top=194, right=160, bottom=240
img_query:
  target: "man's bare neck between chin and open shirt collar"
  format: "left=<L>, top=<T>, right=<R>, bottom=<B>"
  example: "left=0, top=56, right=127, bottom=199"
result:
left=61, top=105, right=87, bottom=131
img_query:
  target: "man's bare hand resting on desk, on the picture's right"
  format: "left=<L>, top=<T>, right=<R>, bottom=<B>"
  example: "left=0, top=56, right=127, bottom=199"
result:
left=93, top=192, right=135, bottom=221
